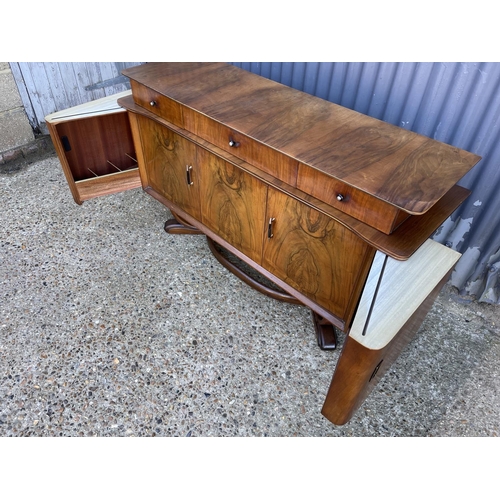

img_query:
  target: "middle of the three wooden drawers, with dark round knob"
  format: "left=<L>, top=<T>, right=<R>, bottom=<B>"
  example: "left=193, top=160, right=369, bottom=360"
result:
left=183, top=108, right=298, bottom=187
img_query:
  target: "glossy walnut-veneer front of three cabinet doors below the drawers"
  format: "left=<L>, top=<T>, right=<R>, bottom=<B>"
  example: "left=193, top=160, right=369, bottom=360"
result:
left=136, top=108, right=375, bottom=325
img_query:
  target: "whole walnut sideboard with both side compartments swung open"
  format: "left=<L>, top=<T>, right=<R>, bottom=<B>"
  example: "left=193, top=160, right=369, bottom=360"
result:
left=47, top=63, right=480, bottom=425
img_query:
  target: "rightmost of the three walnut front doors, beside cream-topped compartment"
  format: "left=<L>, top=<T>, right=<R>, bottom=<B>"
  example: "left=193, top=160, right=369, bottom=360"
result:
left=262, top=187, right=373, bottom=323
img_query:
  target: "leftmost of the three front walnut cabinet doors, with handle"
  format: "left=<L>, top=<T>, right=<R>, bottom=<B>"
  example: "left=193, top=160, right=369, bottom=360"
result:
left=137, top=115, right=201, bottom=220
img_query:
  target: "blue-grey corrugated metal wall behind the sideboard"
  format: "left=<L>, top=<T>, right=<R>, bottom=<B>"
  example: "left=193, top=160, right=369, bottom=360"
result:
left=232, top=62, right=500, bottom=304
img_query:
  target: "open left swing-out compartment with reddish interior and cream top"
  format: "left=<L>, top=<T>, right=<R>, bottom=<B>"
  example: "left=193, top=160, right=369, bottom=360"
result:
left=45, top=91, right=141, bottom=204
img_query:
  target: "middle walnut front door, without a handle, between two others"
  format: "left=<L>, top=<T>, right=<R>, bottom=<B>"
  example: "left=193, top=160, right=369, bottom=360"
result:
left=197, top=148, right=267, bottom=264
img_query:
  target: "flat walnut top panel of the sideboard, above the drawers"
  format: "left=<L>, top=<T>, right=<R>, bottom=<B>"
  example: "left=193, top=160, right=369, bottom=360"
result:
left=123, top=63, right=481, bottom=215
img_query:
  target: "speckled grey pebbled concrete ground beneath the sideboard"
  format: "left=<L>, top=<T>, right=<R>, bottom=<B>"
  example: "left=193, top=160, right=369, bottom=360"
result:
left=0, top=154, right=500, bottom=437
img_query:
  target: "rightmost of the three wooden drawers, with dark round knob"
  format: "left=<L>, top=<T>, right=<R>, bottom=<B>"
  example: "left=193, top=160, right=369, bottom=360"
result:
left=297, top=163, right=410, bottom=234
